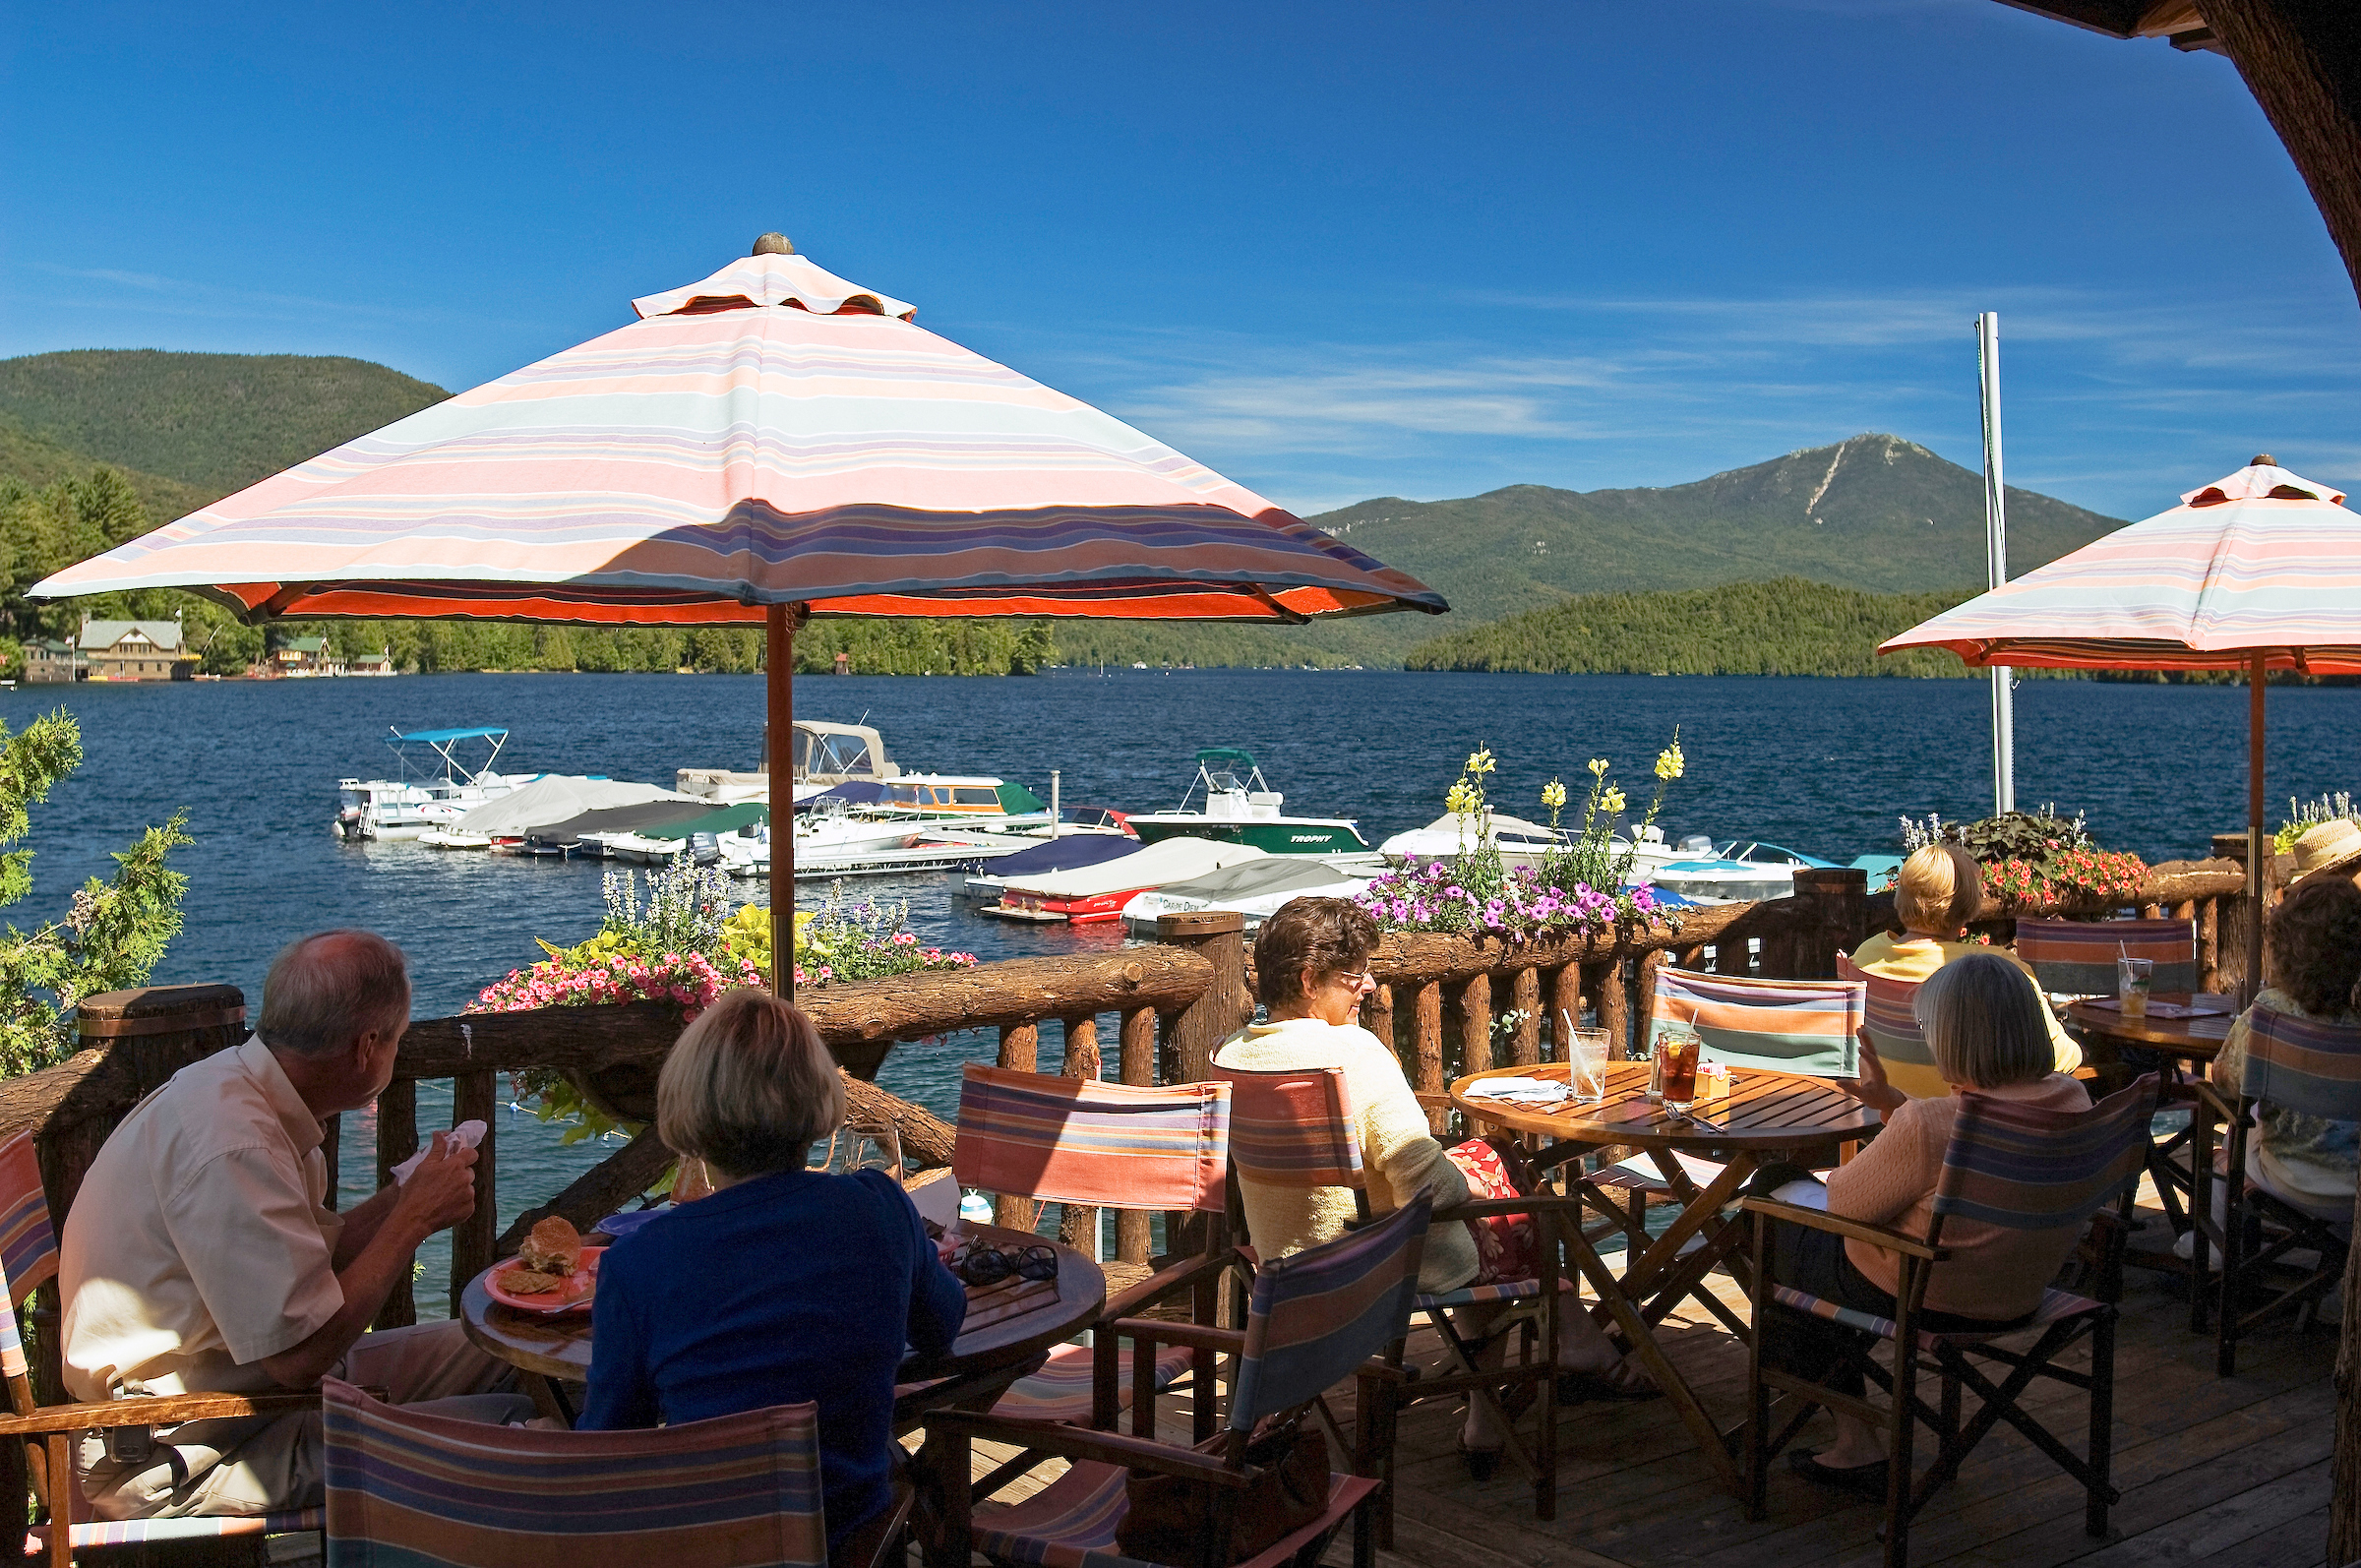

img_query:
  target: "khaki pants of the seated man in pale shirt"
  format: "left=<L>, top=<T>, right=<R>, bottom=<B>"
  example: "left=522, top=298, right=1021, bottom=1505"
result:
left=83, top=1320, right=533, bottom=1519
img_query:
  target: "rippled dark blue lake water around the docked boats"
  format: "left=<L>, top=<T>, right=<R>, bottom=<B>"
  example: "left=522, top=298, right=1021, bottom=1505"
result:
left=0, top=671, right=2361, bottom=1301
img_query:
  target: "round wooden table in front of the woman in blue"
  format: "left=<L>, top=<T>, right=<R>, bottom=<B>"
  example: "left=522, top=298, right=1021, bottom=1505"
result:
left=460, top=1226, right=1108, bottom=1431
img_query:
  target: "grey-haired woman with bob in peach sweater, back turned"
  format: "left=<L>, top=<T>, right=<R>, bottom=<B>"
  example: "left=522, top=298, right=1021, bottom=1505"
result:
left=1752, top=951, right=2089, bottom=1497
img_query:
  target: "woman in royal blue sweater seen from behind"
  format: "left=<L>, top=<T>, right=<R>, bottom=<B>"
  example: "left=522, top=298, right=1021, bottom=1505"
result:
left=578, top=990, right=968, bottom=1546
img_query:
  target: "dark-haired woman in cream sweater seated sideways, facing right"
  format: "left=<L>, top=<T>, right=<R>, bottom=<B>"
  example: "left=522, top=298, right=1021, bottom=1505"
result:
left=1214, top=897, right=1658, bottom=1480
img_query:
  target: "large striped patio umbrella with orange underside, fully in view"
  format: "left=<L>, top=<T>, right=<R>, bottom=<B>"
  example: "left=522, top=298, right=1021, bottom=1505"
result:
left=33, top=234, right=1445, bottom=995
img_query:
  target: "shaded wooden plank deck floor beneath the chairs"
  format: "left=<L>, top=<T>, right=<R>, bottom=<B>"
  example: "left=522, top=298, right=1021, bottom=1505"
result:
left=958, top=1194, right=2335, bottom=1568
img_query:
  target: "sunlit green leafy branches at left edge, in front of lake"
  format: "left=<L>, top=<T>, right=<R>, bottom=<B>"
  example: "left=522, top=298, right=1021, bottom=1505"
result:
left=0, top=708, right=189, bottom=1074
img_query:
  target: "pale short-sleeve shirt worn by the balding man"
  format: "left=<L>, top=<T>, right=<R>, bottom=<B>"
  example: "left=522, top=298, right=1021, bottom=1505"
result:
left=59, top=1034, right=344, bottom=1401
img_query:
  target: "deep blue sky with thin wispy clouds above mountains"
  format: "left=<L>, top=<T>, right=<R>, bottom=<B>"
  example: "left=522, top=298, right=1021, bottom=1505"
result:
left=0, top=0, right=2361, bottom=517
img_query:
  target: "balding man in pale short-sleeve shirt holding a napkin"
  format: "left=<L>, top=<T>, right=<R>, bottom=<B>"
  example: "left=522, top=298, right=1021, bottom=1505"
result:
left=59, top=931, right=531, bottom=1519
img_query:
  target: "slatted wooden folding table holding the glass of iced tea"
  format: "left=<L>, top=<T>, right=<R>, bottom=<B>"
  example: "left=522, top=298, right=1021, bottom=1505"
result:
left=1452, top=1062, right=1877, bottom=1490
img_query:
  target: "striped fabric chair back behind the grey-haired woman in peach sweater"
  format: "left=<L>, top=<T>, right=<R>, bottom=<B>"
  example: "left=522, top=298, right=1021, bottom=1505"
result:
left=1929, top=1072, right=2155, bottom=1242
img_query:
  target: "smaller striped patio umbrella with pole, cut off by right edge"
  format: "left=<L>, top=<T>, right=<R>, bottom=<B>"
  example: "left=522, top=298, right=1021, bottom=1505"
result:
left=1877, top=455, right=2361, bottom=992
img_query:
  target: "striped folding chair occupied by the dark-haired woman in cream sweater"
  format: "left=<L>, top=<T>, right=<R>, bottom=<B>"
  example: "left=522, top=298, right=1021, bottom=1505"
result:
left=1216, top=1067, right=1580, bottom=1546
